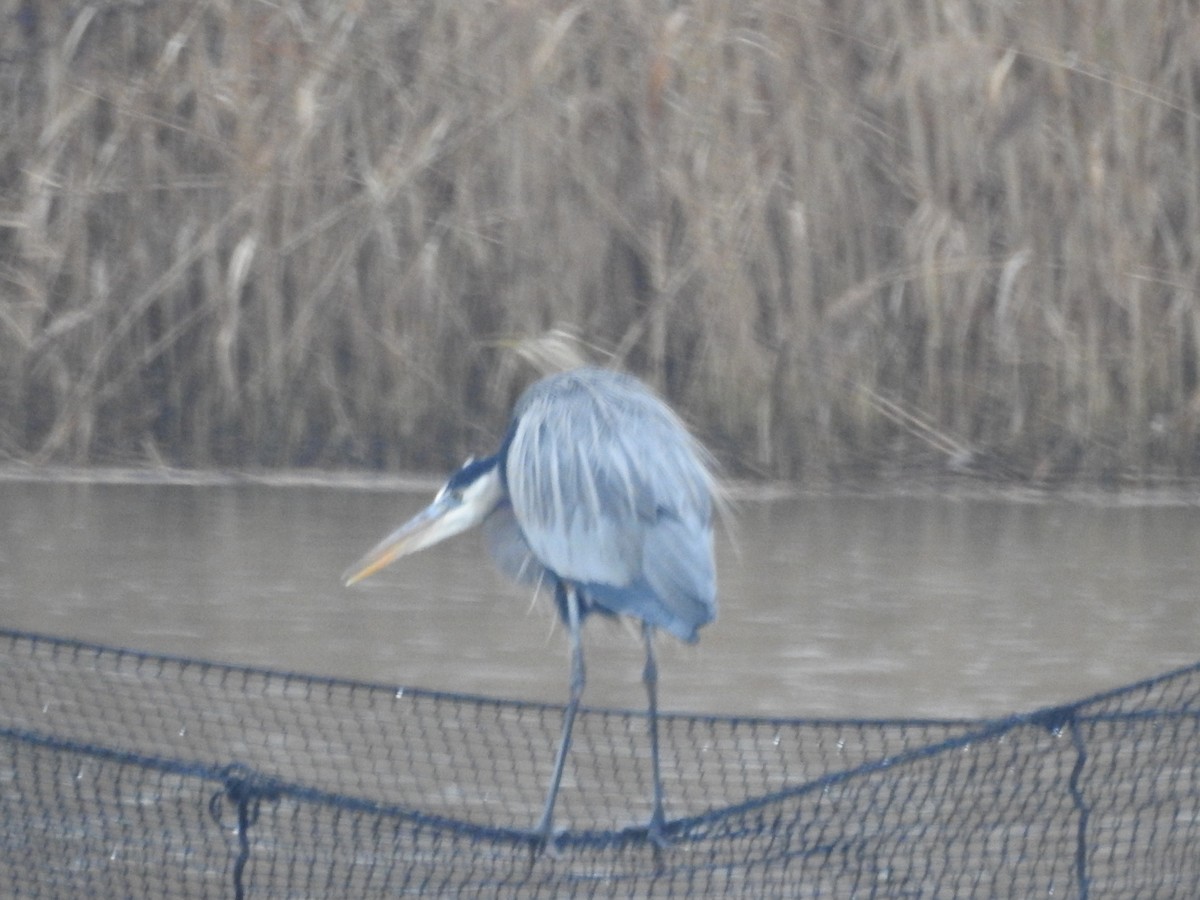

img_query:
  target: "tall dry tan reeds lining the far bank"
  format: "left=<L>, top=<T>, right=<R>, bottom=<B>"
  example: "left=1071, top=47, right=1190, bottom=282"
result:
left=0, top=0, right=1200, bottom=479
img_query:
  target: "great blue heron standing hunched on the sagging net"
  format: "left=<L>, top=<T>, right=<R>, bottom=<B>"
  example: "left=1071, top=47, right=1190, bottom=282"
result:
left=344, top=368, right=716, bottom=847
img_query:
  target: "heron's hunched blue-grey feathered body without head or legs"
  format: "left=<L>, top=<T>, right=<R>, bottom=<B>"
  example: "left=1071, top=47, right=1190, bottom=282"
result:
left=494, top=368, right=716, bottom=641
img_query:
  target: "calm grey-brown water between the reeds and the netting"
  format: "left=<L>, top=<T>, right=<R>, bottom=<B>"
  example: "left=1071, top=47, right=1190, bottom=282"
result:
left=0, top=480, right=1200, bottom=716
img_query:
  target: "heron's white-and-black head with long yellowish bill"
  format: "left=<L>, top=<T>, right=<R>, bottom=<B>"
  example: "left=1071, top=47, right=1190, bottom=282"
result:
left=342, top=456, right=504, bottom=587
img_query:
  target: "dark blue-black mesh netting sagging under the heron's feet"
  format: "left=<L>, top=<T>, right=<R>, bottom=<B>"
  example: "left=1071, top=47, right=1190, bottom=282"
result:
left=0, top=631, right=1200, bottom=898
